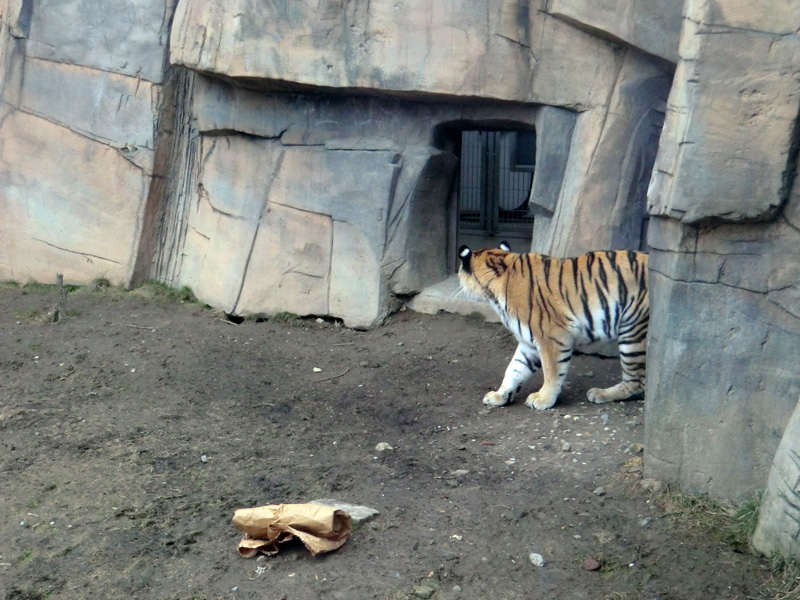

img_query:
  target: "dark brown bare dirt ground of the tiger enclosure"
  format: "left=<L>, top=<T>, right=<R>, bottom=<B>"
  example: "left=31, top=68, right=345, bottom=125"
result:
left=0, top=285, right=769, bottom=600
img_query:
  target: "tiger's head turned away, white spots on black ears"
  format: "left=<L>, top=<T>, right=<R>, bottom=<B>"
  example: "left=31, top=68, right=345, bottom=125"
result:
left=458, top=242, right=518, bottom=302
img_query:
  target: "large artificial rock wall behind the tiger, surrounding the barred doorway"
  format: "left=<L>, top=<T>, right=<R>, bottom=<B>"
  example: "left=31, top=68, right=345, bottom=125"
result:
left=0, top=0, right=680, bottom=327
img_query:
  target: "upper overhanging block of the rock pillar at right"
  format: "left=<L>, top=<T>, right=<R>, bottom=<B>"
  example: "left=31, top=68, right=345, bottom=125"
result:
left=649, top=0, right=800, bottom=223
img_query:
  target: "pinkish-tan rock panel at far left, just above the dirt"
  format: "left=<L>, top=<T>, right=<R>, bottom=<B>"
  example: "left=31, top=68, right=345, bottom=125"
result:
left=0, top=111, right=149, bottom=283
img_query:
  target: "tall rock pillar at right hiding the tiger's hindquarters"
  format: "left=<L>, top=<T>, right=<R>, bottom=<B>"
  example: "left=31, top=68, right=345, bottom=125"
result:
left=645, top=0, right=800, bottom=500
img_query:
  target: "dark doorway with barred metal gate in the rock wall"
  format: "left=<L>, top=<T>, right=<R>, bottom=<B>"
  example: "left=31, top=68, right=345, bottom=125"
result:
left=456, top=129, right=536, bottom=252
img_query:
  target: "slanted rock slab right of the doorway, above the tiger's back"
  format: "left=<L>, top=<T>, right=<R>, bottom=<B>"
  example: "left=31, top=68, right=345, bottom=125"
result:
left=533, top=51, right=670, bottom=256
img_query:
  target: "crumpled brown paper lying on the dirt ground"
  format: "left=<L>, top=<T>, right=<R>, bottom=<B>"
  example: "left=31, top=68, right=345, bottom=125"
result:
left=233, top=504, right=352, bottom=558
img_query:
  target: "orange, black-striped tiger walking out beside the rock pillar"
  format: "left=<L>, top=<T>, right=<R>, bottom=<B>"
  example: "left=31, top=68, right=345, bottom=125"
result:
left=458, top=242, right=650, bottom=410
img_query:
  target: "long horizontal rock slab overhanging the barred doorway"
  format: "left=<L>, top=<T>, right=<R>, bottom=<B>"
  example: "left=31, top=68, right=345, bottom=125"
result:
left=171, top=0, right=624, bottom=106
